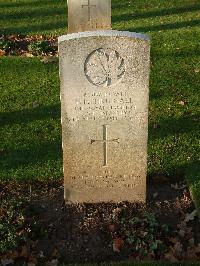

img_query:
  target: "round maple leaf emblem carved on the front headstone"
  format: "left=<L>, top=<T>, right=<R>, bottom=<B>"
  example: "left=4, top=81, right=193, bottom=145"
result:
left=84, top=48, right=125, bottom=87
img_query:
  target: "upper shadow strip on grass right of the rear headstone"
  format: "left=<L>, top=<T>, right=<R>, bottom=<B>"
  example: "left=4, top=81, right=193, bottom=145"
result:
left=112, top=4, right=200, bottom=22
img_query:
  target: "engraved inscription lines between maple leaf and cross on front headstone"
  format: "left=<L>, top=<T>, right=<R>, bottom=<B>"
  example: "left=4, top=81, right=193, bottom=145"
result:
left=69, top=91, right=147, bottom=122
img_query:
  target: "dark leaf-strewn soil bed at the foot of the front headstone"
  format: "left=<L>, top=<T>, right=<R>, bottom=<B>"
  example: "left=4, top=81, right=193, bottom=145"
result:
left=0, top=176, right=200, bottom=264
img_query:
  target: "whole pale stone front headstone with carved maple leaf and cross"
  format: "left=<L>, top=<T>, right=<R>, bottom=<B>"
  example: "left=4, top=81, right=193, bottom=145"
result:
left=59, top=31, right=150, bottom=203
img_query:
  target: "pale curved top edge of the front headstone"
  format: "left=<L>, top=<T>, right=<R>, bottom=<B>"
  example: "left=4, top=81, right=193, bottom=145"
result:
left=58, top=30, right=150, bottom=43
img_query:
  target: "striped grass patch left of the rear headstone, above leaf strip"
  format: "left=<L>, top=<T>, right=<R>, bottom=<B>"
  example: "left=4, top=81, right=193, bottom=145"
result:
left=0, top=0, right=67, bottom=35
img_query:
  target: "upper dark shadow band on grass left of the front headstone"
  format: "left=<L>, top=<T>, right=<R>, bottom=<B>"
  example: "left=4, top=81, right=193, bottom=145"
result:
left=0, top=104, right=61, bottom=126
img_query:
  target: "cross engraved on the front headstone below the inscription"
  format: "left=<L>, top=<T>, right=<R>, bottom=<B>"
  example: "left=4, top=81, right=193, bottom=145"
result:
left=91, top=125, right=119, bottom=166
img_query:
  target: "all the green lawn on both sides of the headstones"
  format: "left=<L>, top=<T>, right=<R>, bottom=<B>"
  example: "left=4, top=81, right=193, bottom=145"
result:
left=0, top=0, right=200, bottom=206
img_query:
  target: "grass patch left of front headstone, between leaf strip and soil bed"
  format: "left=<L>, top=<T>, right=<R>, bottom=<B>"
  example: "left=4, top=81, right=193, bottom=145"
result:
left=0, top=57, right=62, bottom=180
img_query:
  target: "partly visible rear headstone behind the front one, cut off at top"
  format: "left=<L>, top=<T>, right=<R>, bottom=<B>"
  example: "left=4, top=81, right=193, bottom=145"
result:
left=68, top=0, right=111, bottom=33
